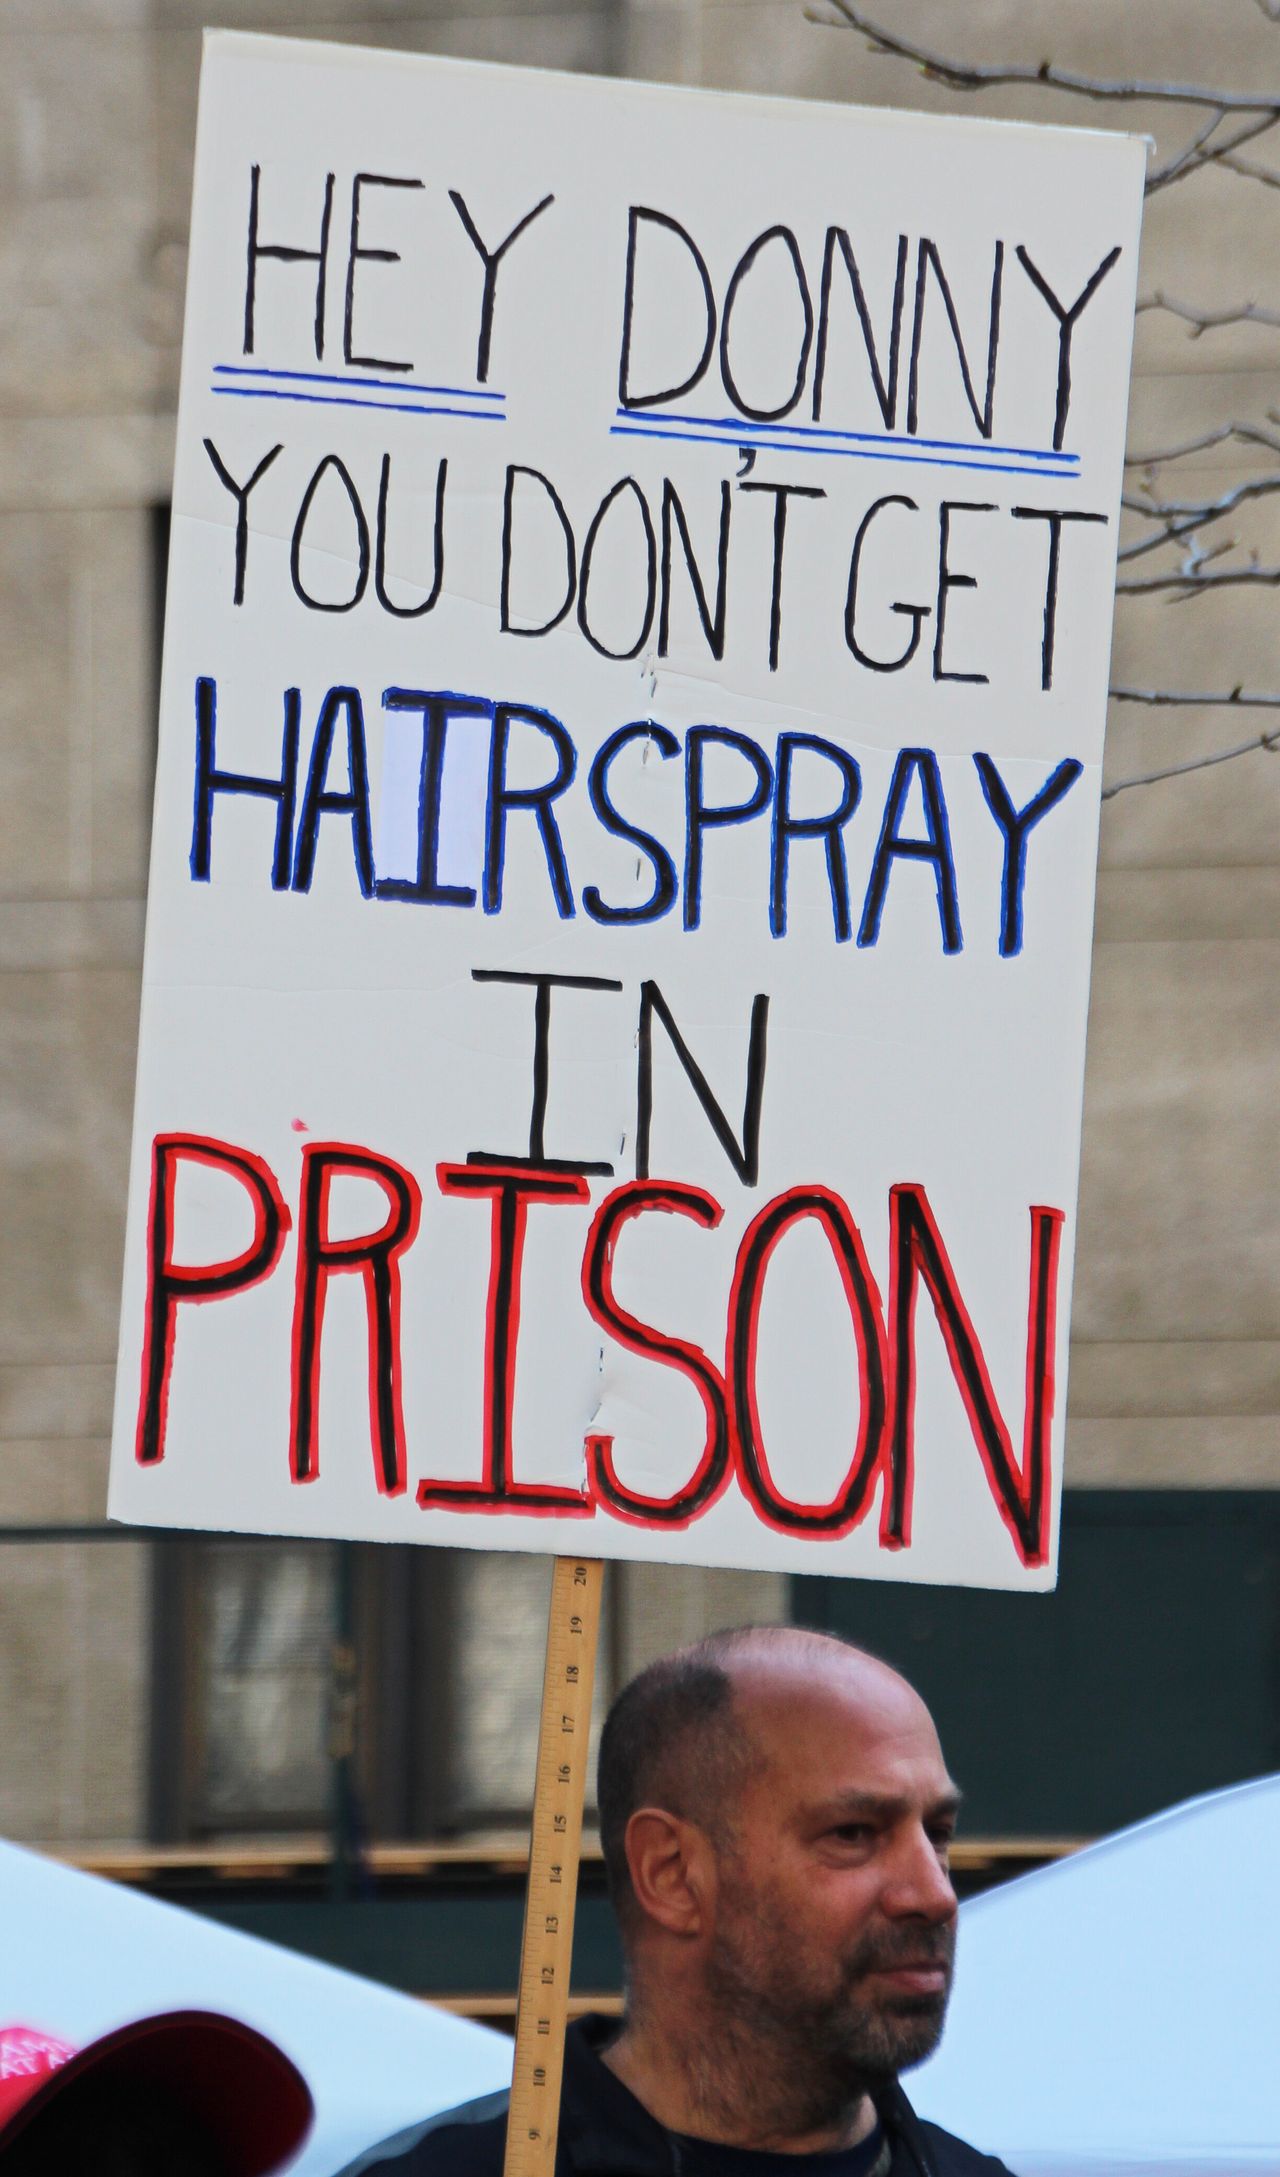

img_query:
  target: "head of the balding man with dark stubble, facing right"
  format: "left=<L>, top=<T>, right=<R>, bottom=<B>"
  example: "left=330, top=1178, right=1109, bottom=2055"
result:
left=599, top=1626, right=958, bottom=2120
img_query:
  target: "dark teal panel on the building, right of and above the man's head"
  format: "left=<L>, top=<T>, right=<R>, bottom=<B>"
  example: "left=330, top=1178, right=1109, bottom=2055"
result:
left=792, top=1489, right=1280, bottom=1837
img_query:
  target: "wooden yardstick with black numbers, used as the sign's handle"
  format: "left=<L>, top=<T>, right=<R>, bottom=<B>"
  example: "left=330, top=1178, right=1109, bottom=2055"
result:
left=503, top=1557, right=605, bottom=2177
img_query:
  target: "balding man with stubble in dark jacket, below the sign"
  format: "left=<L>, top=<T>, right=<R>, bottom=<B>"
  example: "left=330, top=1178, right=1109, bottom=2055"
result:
left=343, top=1626, right=1008, bottom=2177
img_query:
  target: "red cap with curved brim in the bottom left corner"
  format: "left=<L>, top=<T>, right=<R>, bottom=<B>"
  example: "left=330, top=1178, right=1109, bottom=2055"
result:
left=0, top=2012, right=313, bottom=2177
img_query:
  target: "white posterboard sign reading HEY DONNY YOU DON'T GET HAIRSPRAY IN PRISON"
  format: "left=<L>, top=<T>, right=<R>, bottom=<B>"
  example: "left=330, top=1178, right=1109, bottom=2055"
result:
left=111, top=33, right=1143, bottom=1589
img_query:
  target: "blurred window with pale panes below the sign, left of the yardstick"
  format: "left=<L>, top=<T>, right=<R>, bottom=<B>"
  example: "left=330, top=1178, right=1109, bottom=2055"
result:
left=150, top=1535, right=612, bottom=1844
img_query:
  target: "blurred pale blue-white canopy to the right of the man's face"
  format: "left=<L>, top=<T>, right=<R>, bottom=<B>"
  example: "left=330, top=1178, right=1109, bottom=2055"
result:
left=908, top=1776, right=1280, bottom=2177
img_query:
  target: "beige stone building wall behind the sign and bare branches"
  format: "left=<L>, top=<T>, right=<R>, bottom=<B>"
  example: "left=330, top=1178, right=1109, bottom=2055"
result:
left=0, top=0, right=1280, bottom=1842
